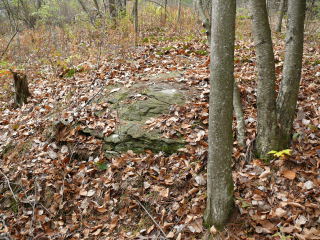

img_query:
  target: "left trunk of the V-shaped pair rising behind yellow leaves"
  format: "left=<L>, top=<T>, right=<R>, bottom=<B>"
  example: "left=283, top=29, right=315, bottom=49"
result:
left=250, top=0, right=278, bottom=158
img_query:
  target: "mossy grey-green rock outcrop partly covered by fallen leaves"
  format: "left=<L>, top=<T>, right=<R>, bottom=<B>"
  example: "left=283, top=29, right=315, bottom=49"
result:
left=100, top=79, right=186, bottom=154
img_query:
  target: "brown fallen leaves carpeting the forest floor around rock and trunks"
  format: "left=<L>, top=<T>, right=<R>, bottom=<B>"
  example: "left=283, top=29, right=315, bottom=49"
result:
left=0, top=23, right=320, bottom=240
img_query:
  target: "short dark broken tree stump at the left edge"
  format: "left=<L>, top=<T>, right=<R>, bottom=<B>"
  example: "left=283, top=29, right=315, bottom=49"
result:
left=10, top=70, right=31, bottom=107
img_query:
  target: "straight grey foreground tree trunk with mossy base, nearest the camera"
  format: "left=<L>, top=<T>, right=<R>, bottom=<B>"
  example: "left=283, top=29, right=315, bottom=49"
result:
left=204, top=0, right=236, bottom=230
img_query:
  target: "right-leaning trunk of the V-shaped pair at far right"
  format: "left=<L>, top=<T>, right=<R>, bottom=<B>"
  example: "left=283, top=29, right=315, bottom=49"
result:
left=277, top=0, right=306, bottom=149
